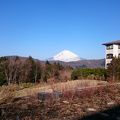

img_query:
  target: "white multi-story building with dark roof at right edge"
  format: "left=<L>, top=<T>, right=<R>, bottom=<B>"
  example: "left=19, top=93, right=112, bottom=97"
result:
left=103, top=40, right=120, bottom=68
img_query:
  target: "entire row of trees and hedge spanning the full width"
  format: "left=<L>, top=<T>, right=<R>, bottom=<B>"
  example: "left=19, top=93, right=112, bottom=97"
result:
left=0, top=56, right=120, bottom=85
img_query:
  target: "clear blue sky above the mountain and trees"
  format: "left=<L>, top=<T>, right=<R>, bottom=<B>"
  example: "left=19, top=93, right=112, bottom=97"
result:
left=0, top=0, right=120, bottom=59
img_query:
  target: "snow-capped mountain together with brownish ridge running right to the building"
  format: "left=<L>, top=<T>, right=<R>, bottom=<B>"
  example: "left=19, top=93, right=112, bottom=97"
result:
left=48, top=50, right=105, bottom=68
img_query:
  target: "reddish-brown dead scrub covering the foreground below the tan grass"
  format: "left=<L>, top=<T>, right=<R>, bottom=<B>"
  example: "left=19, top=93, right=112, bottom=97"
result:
left=0, top=85, right=120, bottom=120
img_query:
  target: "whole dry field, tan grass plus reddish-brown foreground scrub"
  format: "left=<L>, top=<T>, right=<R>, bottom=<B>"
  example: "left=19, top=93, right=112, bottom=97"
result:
left=0, top=80, right=120, bottom=120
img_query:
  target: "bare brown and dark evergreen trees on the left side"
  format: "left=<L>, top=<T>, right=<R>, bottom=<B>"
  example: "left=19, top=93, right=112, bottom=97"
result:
left=0, top=56, right=70, bottom=85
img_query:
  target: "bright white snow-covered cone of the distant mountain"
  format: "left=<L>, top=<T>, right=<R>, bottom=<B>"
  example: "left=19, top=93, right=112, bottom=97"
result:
left=52, top=50, right=81, bottom=62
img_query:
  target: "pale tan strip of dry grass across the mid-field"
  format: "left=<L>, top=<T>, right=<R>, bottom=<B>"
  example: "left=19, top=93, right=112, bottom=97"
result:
left=10, top=80, right=106, bottom=97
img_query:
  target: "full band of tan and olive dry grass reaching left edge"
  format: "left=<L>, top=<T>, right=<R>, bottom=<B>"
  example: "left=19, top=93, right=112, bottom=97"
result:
left=0, top=80, right=105, bottom=104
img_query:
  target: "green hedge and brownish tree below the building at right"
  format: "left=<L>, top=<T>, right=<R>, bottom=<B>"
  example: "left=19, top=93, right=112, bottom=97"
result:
left=71, top=58, right=120, bottom=82
